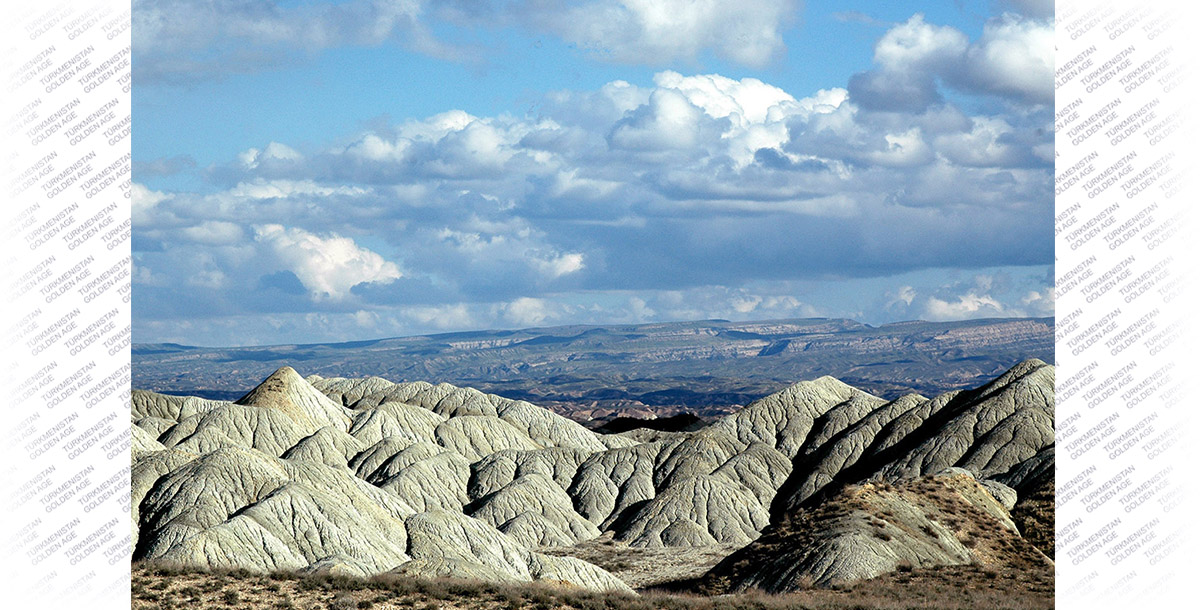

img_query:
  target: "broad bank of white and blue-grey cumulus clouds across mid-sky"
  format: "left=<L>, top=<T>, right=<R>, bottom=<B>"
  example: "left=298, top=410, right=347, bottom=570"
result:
left=133, top=60, right=1052, bottom=333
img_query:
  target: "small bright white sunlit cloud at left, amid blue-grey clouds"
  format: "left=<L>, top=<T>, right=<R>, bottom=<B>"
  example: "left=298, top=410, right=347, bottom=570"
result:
left=254, top=225, right=402, bottom=299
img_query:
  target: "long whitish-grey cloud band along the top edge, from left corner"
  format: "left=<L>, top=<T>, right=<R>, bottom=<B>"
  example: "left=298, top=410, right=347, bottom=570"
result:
left=133, top=0, right=799, bottom=82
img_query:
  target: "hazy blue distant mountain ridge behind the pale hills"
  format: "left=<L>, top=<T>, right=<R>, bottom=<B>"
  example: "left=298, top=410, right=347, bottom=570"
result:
left=132, top=318, right=1054, bottom=420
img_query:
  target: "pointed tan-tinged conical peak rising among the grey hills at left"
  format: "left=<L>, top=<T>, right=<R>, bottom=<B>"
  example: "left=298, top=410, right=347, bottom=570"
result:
left=234, top=366, right=350, bottom=432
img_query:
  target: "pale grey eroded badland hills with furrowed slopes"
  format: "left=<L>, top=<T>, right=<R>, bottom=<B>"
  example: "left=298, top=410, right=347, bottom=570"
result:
left=132, top=360, right=1054, bottom=592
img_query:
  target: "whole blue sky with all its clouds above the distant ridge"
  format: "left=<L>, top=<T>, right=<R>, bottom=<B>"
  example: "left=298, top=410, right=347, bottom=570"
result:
left=132, top=0, right=1054, bottom=346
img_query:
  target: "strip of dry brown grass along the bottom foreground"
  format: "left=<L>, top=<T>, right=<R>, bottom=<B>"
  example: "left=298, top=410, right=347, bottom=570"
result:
left=131, top=564, right=1054, bottom=610
